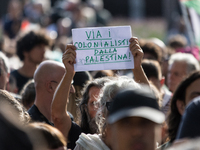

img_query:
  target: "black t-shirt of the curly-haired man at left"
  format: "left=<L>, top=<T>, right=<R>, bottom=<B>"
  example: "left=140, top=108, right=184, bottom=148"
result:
left=10, top=70, right=33, bottom=93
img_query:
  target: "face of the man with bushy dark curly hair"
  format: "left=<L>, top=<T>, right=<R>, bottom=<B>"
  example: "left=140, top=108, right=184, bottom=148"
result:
left=27, top=44, right=46, bottom=64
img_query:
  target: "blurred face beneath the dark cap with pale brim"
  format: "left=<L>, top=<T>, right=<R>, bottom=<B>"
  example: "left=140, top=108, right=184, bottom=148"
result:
left=107, top=117, right=161, bottom=150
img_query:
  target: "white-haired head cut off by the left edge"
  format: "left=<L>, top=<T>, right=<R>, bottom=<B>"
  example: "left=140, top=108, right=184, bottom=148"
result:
left=0, top=52, right=10, bottom=90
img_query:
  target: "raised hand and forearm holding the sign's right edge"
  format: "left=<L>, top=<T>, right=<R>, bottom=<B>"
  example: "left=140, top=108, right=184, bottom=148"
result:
left=129, top=37, right=149, bottom=85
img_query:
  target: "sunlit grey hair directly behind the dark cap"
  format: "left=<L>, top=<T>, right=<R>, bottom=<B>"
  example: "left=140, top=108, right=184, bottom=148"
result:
left=95, top=76, right=140, bottom=134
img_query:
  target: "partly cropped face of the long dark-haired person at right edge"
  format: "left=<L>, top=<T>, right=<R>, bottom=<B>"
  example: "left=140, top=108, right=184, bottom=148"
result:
left=185, top=79, right=200, bottom=105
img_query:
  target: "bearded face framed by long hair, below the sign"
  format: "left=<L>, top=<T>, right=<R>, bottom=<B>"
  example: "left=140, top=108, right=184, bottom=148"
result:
left=87, top=86, right=100, bottom=119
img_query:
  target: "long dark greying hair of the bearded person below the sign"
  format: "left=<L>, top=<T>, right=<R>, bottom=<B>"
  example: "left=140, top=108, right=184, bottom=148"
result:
left=79, top=77, right=110, bottom=134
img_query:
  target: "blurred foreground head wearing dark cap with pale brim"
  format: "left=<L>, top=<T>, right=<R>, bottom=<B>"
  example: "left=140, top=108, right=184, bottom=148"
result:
left=106, top=88, right=165, bottom=150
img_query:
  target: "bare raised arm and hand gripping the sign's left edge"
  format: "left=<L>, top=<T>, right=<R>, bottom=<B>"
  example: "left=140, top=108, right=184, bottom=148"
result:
left=51, top=45, right=76, bottom=139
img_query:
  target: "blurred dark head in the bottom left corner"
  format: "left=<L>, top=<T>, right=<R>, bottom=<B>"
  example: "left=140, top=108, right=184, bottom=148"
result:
left=0, top=103, right=33, bottom=150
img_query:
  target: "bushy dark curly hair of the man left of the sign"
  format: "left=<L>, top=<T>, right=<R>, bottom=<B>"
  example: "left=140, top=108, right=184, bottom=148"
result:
left=17, top=31, right=49, bottom=61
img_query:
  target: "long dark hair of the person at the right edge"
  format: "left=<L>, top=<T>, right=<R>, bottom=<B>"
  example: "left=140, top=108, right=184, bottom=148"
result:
left=168, top=71, right=200, bottom=142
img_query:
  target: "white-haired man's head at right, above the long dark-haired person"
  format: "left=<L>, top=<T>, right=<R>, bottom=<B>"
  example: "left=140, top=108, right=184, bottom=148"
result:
left=167, top=53, right=199, bottom=93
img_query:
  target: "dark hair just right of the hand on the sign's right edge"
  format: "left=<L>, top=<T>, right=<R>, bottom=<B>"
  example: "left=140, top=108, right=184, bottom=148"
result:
left=139, top=39, right=162, bottom=63
